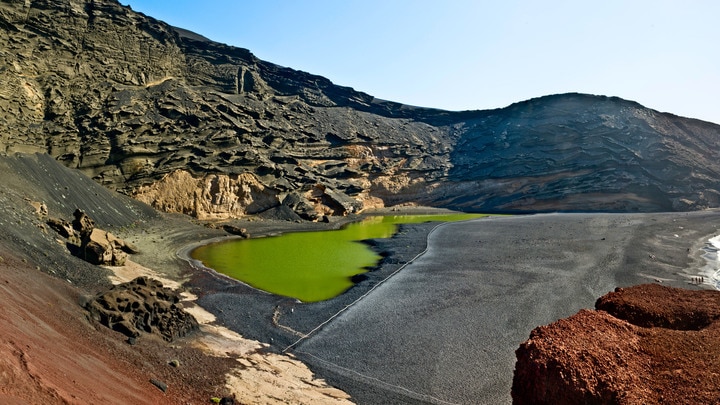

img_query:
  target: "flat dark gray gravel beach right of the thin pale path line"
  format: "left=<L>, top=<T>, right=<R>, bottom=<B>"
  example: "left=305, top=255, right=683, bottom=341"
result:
left=293, top=212, right=720, bottom=404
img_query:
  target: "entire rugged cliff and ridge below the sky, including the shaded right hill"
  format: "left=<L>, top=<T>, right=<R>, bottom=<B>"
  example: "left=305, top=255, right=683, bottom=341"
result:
left=0, top=0, right=720, bottom=219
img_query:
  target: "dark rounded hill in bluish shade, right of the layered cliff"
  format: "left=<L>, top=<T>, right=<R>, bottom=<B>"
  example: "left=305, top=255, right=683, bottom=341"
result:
left=445, top=94, right=720, bottom=211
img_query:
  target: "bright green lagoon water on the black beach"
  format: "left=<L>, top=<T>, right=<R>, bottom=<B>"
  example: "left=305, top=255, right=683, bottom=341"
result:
left=191, top=214, right=483, bottom=302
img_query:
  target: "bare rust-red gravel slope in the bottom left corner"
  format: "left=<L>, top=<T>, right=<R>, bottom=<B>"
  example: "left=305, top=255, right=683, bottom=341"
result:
left=0, top=246, right=237, bottom=405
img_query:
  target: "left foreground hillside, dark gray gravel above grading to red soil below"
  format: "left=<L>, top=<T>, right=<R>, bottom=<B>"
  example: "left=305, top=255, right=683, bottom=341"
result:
left=0, top=155, right=234, bottom=404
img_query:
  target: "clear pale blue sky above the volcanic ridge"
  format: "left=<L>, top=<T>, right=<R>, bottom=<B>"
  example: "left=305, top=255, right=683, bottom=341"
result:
left=121, top=0, right=720, bottom=123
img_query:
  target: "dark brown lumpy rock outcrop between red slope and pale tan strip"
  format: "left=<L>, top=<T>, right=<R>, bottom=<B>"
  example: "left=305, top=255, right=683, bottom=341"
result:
left=85, top=277, right=199, bottom=341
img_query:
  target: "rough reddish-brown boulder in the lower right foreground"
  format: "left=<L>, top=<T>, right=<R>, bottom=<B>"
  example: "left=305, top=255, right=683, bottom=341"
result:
left=512, top=284, right=720, bottom=404
